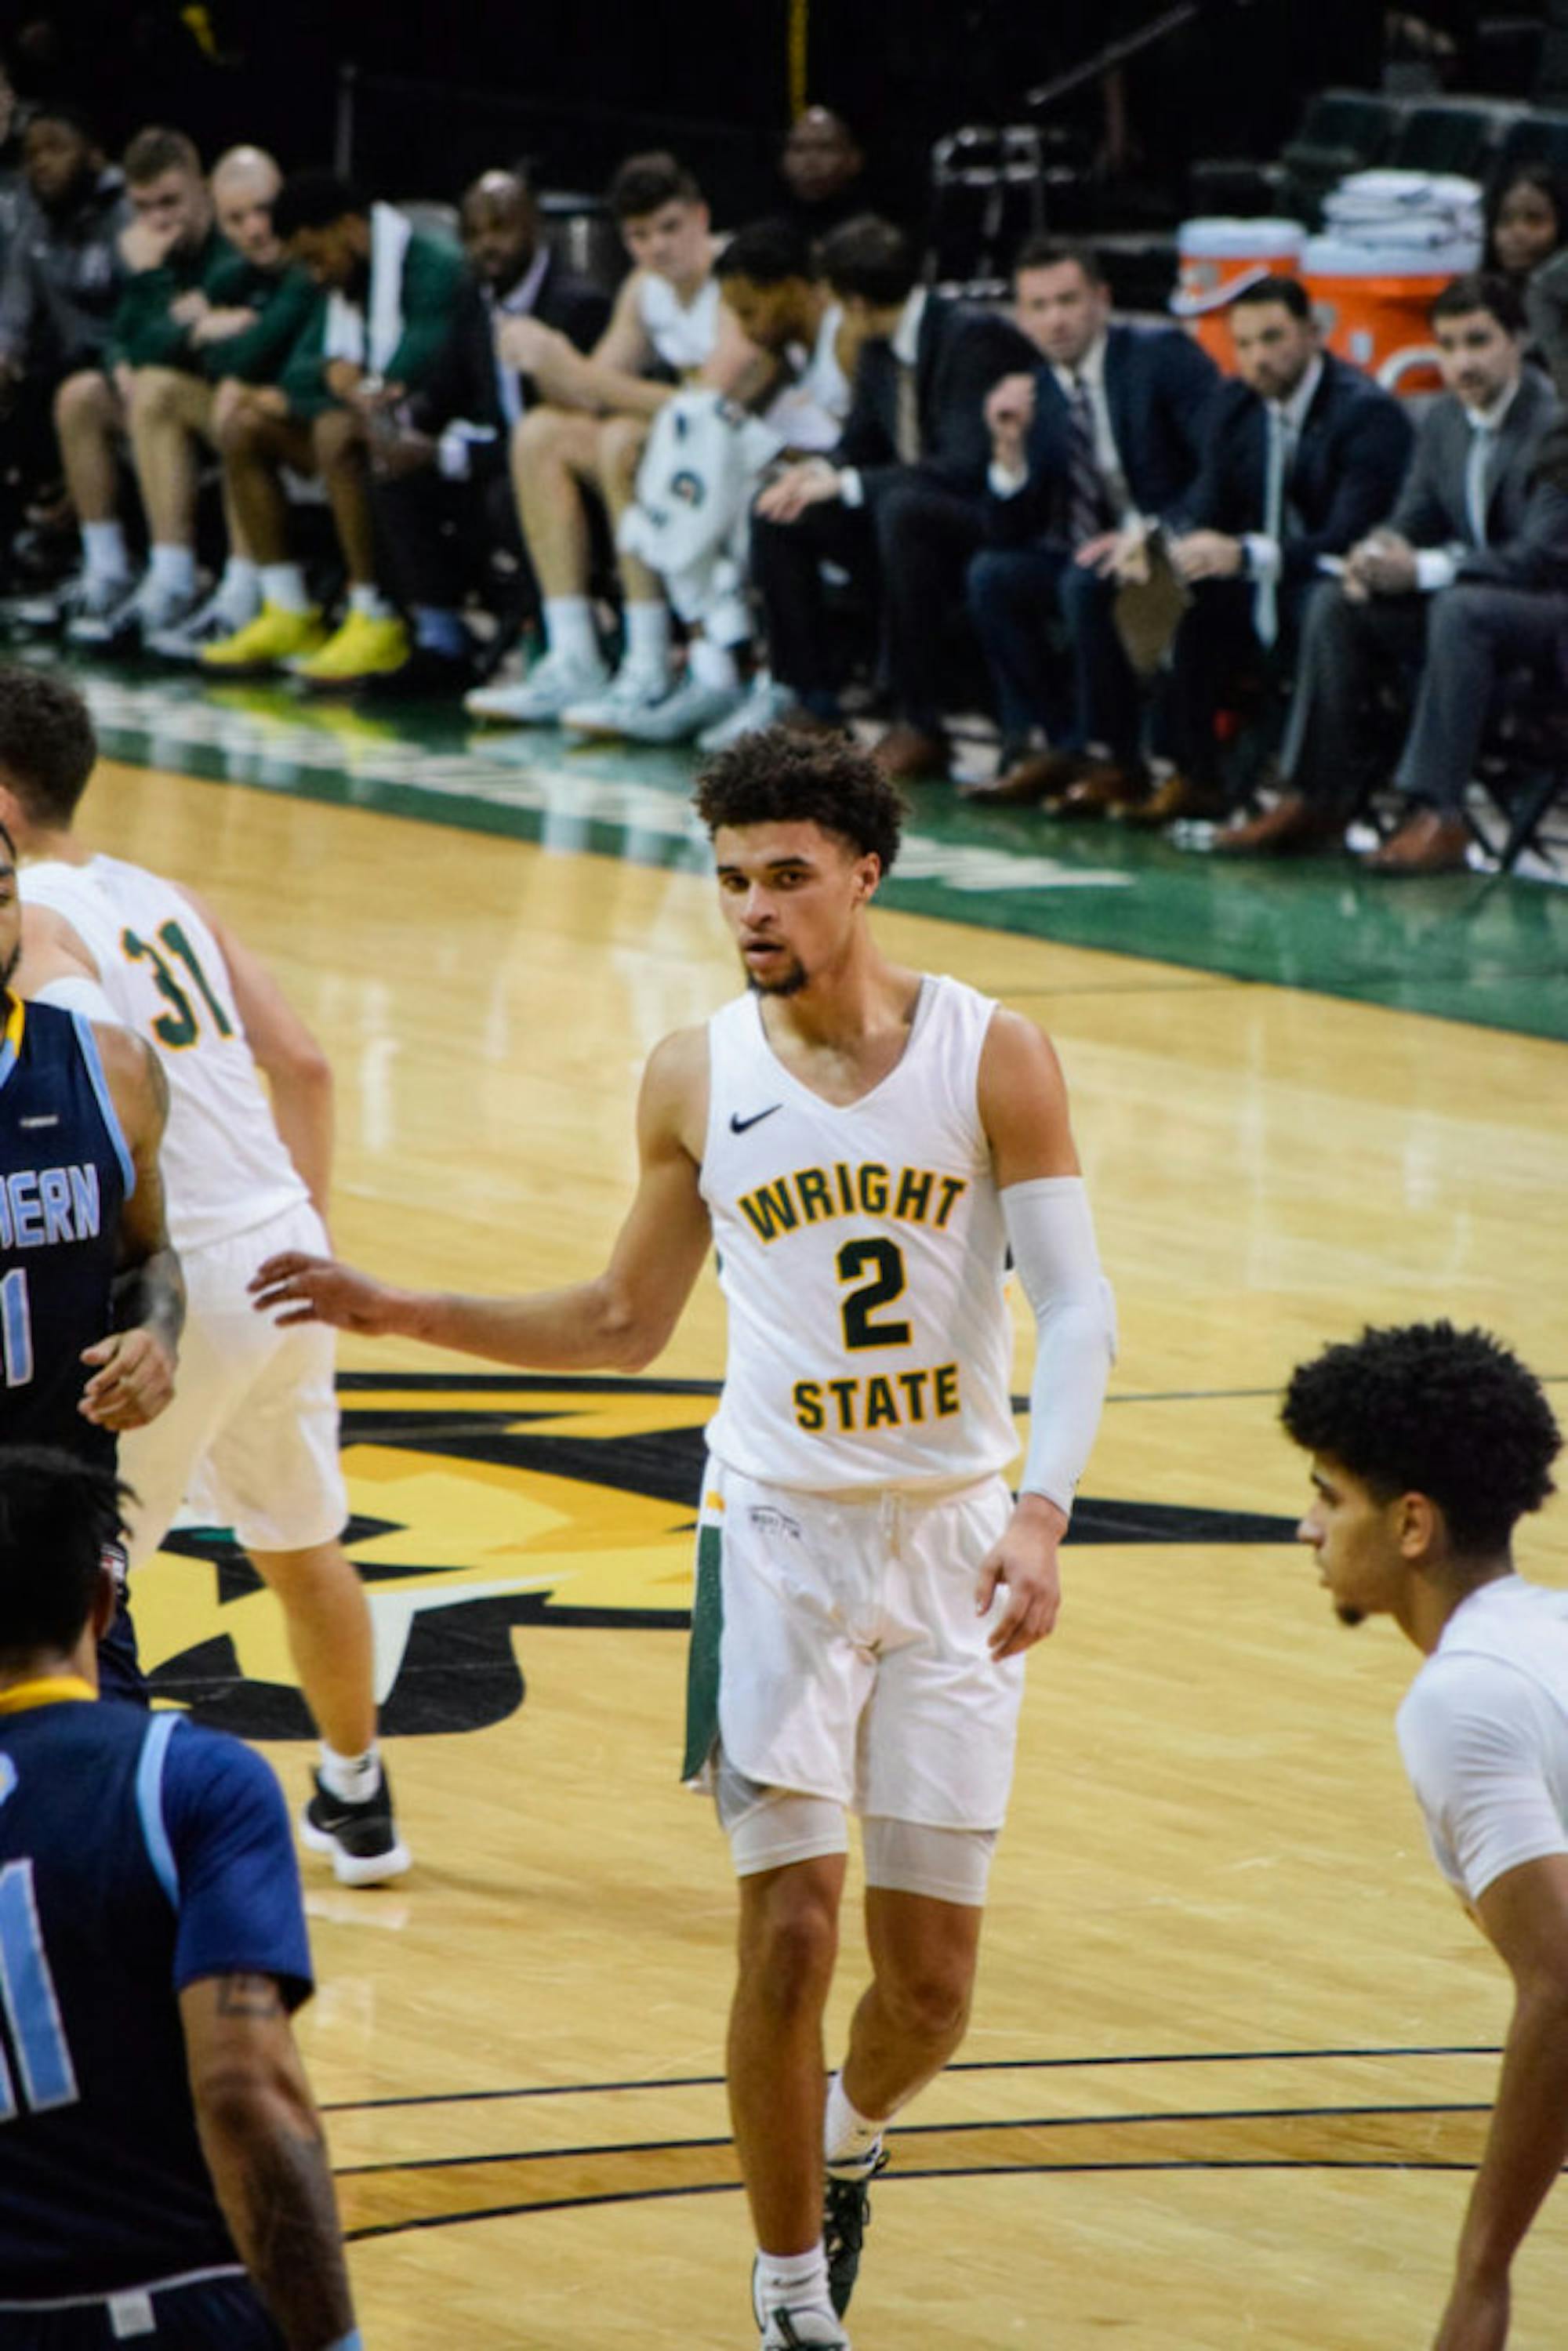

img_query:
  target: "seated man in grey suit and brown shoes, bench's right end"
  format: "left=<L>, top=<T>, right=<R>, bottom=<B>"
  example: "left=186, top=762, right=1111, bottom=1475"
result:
left=1215, top=275, right=1568, bottom=875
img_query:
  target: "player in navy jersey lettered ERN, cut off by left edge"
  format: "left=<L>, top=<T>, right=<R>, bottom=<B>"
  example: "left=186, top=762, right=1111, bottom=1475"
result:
left=0, top=823, right=183, bottom=1697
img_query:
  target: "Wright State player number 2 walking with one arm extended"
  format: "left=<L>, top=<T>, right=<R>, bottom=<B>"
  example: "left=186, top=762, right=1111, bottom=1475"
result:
left=256, top=729, right=1114, bottom=2351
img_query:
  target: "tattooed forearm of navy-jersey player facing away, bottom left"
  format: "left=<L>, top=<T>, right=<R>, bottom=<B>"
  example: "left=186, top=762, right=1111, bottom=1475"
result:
left=198, top=2078, right=355, bottom=2351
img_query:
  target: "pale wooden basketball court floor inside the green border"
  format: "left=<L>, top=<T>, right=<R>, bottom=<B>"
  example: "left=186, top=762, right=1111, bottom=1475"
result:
left=89, top=769, right=1568, bottom=2351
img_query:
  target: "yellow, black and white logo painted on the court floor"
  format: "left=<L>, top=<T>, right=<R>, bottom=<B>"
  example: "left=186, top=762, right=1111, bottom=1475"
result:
left=143, top=1373, right=1295, bottom=1740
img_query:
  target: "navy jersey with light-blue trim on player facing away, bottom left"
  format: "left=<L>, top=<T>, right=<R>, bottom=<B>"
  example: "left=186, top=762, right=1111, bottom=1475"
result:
left=0, top=1681, right=310, bottom=2339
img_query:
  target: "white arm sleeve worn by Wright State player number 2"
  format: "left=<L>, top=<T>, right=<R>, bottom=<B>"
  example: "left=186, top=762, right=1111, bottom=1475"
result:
left=1001, top=1176, right=1116, bottom=1514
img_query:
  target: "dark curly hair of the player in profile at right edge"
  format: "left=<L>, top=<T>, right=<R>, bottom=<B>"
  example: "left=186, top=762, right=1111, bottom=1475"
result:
left=1279, top=1321, right=1563, bottom=1556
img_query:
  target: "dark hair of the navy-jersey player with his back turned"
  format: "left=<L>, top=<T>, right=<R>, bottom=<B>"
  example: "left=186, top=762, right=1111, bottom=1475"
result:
left=0, top=1446, right=127, bottom=1657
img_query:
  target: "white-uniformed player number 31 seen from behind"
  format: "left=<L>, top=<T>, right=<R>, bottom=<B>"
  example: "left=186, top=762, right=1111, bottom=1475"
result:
left=0, top=668, right=409, bottom=1885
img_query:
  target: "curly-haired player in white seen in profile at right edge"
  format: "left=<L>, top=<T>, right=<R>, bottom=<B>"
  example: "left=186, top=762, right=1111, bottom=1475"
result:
left=1281, top=1321, right=1568, bottom=2351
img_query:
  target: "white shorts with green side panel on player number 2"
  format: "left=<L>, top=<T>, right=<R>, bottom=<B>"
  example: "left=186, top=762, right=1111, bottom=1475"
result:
left=684, top=1460, right=1022, bottom=1829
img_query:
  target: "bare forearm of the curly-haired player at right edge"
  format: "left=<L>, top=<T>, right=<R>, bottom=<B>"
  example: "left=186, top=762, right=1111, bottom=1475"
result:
left=1457, top=1982, right=1568, bottom=2278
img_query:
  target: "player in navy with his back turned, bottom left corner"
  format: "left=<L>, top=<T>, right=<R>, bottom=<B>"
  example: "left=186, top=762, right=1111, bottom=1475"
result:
left=0, top=1446, right=360, bottom=2351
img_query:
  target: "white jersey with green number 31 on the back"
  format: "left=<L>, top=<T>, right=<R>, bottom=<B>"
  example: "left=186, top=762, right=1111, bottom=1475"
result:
left=21, top=858, right=310, bottom=1250
